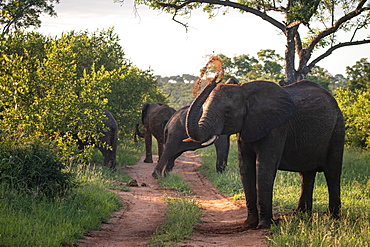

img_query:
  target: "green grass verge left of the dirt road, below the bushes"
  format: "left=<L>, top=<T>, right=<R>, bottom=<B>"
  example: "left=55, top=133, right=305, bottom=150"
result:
left=0, top=140, right=142, bottom=247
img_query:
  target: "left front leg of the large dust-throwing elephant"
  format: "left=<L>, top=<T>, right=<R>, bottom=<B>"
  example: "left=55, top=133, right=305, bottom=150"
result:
left=238, top=141, right=258, bottom=228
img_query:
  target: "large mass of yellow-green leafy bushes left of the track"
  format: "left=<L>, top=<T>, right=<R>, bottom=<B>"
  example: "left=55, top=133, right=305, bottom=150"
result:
left=0, top=28, right=165, bottom=150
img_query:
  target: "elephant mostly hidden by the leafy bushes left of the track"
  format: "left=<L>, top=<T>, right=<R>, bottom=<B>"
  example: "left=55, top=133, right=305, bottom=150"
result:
left=78, top=109, right=118, bottom=169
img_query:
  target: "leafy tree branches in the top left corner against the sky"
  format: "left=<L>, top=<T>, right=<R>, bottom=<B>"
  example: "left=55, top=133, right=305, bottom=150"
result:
left=0, top=0, right=59, bottom=38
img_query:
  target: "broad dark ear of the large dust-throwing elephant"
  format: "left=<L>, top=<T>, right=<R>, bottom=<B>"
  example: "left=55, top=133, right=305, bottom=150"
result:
left=241, top=81, right=295, bottom=142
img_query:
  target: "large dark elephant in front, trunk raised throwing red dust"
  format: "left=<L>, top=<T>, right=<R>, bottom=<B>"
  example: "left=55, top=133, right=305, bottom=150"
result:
left=186, top=80, right=345, bottom=228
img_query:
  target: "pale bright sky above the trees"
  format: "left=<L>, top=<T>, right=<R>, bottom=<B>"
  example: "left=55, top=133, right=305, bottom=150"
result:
left=36, top=0, right=370, bottom=76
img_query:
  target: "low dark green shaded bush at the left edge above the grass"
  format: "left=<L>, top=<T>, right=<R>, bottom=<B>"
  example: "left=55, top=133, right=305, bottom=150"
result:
left=0, top=139, right=74, bottom=198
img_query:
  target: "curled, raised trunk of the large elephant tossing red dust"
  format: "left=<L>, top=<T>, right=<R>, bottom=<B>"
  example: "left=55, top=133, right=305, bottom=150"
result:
left=186, top=81, right=216, bottom=145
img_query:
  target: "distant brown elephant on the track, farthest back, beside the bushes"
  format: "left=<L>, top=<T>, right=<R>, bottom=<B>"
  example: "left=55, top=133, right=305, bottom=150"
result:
left=136, top=102, right=176, bottom=163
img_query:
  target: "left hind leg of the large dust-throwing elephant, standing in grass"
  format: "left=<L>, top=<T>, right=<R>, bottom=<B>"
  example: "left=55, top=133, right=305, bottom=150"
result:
left=295, top=171, right=316, bottom=212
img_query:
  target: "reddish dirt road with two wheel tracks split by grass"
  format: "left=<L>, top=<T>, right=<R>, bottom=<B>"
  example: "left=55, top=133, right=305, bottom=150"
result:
left=78, top=152, right=267, bottom=247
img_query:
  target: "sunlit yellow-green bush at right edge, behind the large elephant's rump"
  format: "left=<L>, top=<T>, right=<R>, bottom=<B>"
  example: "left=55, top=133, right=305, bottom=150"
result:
left=335, top=88, right=370, bottom=148
